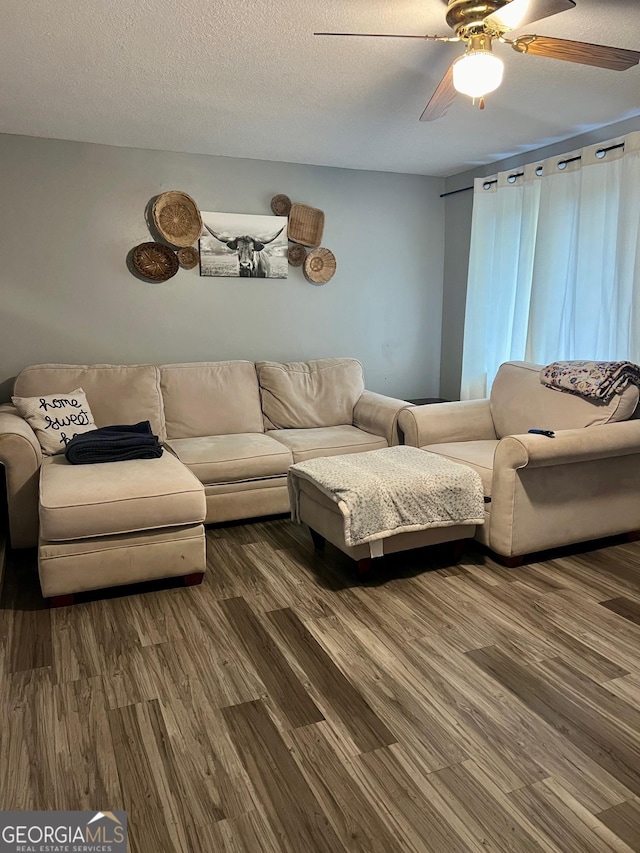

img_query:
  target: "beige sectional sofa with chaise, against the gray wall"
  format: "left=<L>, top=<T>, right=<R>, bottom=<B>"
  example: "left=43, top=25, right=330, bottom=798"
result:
left=0, top=358, right=408, bottom=596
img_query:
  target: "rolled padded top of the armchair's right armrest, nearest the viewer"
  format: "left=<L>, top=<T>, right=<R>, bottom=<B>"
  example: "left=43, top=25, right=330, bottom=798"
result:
left=494, top=420, right=640, bottom=471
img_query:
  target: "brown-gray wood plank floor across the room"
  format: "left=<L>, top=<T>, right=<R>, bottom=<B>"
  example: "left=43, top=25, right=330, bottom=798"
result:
left=0, top=519, right=640, bottom=853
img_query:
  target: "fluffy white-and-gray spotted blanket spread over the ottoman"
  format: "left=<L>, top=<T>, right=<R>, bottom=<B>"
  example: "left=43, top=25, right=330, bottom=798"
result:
left=288, top=447, right=484, bottom=546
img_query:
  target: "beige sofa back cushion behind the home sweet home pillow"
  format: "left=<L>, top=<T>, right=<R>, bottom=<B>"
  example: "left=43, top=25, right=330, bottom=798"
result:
left=13, top=364, right=167, bottom=441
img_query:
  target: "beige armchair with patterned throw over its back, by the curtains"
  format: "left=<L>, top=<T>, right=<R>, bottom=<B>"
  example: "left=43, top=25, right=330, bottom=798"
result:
left=399, top=362, right=640, bottom=565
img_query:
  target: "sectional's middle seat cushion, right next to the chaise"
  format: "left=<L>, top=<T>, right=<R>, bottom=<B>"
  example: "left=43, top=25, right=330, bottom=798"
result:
left=169, top=433, right=293, bottom=485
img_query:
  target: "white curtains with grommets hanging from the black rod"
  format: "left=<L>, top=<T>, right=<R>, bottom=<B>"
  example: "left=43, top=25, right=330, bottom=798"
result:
left=461, top=132, right=640, bottom=400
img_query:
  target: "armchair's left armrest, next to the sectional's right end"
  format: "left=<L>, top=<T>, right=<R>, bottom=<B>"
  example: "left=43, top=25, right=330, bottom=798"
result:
left=399, top=400, right=496, bottom=447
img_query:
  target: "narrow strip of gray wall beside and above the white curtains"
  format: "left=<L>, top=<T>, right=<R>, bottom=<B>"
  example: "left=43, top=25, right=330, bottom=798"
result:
left=440, top=112, right=640, bottom=400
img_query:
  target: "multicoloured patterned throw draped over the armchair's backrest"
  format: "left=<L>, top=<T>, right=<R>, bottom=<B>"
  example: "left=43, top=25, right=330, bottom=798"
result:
left=540, top=361, right=640, bottom=403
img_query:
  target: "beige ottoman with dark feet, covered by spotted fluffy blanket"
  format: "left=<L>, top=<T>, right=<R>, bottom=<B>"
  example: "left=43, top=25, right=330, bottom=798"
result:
left=289, top=447, right=484, bottom=574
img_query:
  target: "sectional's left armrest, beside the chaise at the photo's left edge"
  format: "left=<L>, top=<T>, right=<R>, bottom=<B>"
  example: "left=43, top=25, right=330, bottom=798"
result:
left=0, top=405, right=42, bottom=548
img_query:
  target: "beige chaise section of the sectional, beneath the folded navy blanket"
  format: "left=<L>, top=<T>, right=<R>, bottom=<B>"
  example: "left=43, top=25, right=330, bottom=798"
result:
left=38, top=450, right=206, bottom=606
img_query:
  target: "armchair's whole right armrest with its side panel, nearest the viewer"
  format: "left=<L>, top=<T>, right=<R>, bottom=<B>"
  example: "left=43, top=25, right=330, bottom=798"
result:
left=487, top=421, right=640, bottom=557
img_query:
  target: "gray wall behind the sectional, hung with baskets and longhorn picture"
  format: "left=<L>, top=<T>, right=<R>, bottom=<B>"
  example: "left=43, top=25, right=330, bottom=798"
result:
left=0, top=135, right=444, bottom=398
